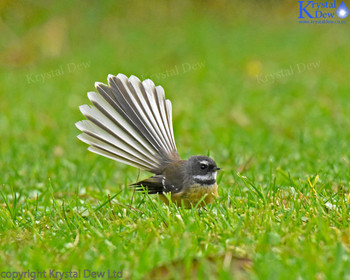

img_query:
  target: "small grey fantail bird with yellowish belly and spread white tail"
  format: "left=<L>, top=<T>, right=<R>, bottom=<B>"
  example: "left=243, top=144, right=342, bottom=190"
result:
left=76, top=74, right=220, bottom=208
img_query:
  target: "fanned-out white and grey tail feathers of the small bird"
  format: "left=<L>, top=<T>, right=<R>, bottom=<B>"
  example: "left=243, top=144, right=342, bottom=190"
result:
left=76, top=74, right=180, bottom=174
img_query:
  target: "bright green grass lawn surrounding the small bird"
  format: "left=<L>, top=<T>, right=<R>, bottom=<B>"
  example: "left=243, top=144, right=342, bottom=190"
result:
left=0, top=1, right=350, bottom=279
